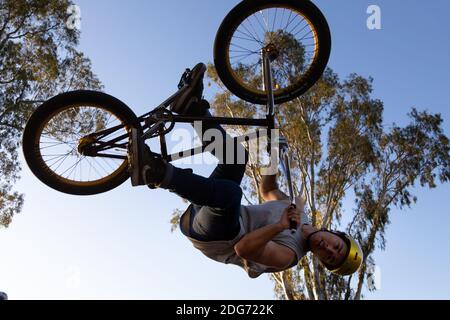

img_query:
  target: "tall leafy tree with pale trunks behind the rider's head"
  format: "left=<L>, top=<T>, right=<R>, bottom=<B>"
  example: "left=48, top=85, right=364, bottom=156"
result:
left=170, top=28, right=450, bottom=300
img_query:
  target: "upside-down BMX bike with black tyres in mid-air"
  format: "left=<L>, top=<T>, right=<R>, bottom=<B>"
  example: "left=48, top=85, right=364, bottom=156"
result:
left=23, top=0, right=331, bottom=195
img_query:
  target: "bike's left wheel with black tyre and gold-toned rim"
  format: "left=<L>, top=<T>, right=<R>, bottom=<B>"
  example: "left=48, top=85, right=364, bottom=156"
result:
left=23, top=91, right=140, bottom=195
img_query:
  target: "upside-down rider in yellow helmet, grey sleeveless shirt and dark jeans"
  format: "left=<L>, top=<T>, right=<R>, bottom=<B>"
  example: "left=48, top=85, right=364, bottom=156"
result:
left=130, top=63, right=362, bottom=278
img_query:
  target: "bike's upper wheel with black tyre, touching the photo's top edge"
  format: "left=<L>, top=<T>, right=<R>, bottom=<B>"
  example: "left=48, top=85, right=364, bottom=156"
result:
left=214, top=0, right=331, bottom=104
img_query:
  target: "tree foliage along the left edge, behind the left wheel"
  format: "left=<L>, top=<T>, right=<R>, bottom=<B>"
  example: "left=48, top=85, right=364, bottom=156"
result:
left=0, top=0, right=101, bottom=226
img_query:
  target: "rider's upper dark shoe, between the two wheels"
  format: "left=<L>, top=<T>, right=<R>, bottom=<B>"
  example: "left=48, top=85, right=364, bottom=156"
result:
left=170, top=63, right=206, bottom=115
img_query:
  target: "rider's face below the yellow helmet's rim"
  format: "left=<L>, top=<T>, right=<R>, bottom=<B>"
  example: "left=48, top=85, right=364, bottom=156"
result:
left=310, top=231, right=348, bottom=267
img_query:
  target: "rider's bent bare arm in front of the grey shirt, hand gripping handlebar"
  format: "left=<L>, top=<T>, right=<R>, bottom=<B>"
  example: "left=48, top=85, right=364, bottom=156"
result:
left=234, top=207, right=300, bottom=269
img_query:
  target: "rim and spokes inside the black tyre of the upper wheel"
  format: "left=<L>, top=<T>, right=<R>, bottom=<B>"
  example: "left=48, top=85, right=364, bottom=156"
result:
left=226, top=5, right=319, bottom=96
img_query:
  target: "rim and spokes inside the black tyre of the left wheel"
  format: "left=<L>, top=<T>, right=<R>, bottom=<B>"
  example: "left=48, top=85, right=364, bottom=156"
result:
left=35, top=104, right=128, bottom=187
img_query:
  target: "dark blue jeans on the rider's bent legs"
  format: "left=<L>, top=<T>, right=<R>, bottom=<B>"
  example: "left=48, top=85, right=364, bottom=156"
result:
left=162, top=100, right=248, bottom=241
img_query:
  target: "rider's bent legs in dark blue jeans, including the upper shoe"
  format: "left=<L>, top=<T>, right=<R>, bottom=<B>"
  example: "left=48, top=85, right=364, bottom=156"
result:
left=144, top=64, right=248, bottom=241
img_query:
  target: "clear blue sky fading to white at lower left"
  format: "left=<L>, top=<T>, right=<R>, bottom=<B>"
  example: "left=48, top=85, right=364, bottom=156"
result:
left=0, top=0, right=450, bottom=299
